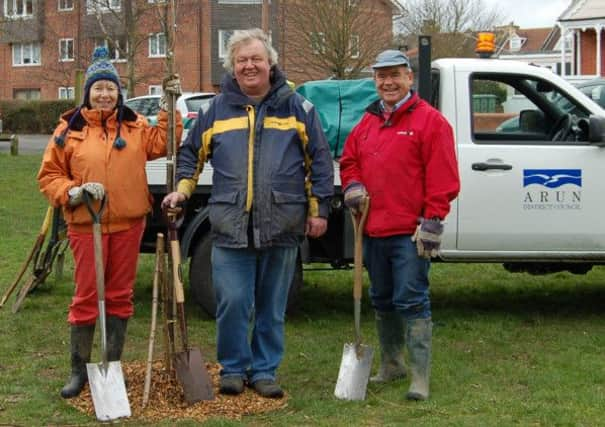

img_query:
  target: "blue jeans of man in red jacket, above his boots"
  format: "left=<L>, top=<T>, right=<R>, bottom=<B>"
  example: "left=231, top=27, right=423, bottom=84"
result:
left=363, top=235, right=431, bottom=320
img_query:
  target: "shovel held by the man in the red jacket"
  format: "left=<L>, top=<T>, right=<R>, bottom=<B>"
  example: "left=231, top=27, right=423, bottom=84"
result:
left=334, top=197, right=374, bottom=400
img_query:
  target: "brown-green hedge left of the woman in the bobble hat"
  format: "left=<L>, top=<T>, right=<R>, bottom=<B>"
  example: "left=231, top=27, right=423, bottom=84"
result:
left=0, top=100, right=74, bottom=134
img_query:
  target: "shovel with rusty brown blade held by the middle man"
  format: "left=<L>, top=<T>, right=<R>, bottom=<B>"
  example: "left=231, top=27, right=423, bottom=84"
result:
left=168, top=215, right=214, bottom=405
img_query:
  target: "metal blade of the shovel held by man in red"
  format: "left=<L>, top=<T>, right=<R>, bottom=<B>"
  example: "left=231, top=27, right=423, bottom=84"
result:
left=334, top=343, right=374, bottom=400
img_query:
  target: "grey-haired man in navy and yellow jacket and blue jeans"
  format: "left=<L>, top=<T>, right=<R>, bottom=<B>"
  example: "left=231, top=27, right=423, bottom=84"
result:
left=163, top=29, right=334, bottom=398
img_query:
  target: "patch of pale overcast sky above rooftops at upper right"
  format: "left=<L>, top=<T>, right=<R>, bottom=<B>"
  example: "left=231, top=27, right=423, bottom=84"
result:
left=483, top=0, right=571, bottom=28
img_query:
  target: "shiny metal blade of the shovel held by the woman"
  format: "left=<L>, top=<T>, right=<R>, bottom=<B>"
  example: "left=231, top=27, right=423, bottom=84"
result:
left=86, top=361, right=131, bottom=421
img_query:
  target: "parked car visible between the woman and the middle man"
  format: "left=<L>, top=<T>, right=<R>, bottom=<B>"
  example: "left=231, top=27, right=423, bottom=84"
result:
left=124, top=92, right=216, bottom=139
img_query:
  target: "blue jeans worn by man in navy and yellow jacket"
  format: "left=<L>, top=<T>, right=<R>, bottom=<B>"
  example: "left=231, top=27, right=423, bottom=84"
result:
left=212, top=245, right=298, bottom=383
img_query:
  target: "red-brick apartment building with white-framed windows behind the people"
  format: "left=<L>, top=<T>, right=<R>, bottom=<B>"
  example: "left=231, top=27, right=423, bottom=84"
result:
left=0, top=0, right=397, bottom=100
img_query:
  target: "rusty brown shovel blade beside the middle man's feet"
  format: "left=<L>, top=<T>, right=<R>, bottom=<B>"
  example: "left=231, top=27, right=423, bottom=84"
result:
left=174, top=347, right=214, bottom=405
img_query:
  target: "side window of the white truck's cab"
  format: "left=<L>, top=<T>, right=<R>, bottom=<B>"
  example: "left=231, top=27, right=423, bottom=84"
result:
left=470, top=74, right=588, bottom=144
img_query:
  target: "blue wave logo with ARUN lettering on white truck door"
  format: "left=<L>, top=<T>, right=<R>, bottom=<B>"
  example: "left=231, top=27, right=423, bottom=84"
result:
left=523, top=169, right=582, bottom=211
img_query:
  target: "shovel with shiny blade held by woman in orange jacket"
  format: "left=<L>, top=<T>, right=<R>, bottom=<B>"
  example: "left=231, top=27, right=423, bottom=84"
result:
left=83, top=196, right=131, bottom=421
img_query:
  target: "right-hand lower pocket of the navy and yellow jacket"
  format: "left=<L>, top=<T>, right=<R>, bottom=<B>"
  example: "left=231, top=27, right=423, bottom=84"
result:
left=271, top=190, right=307, bottom=238
